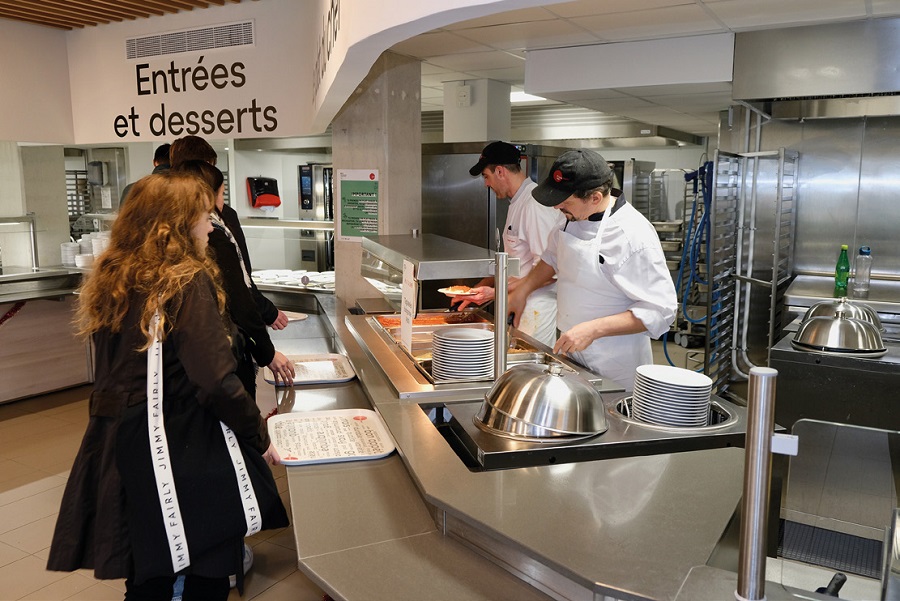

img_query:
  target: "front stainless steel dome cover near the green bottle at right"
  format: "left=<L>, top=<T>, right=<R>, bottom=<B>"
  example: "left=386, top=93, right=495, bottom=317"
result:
left=791, top=308, right=887, bottom=357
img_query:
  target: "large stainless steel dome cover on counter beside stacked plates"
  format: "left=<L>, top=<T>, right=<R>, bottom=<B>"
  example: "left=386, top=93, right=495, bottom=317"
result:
left=475, top=363, right=609, bottom=437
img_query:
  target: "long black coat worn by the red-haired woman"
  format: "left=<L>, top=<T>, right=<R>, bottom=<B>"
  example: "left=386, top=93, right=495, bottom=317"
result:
left=47, top=275, right=287, bottom=581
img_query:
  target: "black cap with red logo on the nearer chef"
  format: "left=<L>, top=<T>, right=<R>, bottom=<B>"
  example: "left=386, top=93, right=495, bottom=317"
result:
left=531, top=149, right=614, bottom=207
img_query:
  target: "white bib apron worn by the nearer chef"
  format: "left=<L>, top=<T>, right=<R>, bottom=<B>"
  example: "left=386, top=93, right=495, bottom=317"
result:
left=556, top=199, right=653, bottom=392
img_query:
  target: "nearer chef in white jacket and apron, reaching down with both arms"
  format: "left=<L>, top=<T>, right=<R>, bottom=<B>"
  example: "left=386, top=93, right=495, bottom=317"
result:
left=509, top=150, right=678, bottom=391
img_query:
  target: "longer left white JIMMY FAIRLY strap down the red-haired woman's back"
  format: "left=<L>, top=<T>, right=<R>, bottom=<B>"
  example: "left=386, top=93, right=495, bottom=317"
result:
left=147, top=313, right=191, bottom=573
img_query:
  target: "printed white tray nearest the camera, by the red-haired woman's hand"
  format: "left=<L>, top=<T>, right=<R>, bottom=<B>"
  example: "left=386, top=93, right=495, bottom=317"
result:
left=266, top=409, right=394, bottom=465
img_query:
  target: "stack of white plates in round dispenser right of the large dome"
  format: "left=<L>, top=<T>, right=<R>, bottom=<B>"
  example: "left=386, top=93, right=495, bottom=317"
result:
left=631, top=365, right=712, bottom=428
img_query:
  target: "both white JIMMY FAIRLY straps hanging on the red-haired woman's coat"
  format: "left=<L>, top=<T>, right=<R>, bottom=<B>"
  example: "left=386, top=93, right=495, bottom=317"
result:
left=147, top=313, right=262, bottom=573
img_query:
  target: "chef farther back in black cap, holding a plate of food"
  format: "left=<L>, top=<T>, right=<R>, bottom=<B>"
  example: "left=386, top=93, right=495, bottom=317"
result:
left=451, top=142, right=566, bottom=346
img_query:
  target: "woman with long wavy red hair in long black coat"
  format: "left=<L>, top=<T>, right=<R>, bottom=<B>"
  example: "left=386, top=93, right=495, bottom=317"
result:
left=47, top=173, right=289, bottom=601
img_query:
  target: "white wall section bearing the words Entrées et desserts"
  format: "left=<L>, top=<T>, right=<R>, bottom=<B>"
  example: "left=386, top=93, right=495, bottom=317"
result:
left=68, top=0, right=315, bottom=144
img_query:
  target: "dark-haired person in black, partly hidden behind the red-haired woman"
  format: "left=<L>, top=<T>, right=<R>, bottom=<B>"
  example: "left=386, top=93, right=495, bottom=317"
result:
left=172, top=160, right=294, bottom=398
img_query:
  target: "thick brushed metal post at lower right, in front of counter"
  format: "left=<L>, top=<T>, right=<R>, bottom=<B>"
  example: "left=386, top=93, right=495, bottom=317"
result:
left=734, top=367, right=778, bottom=601
